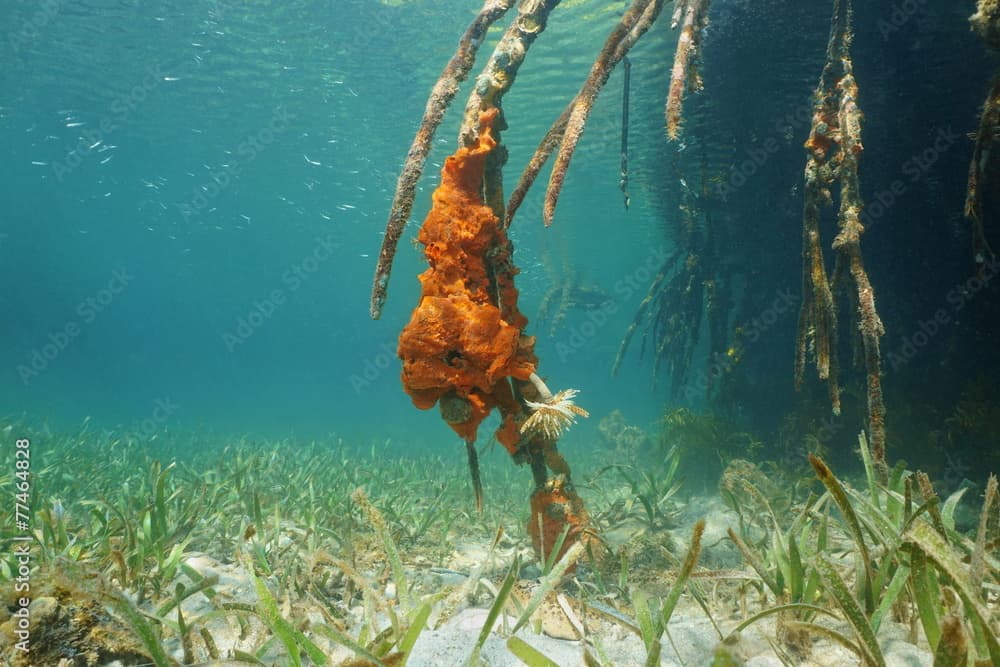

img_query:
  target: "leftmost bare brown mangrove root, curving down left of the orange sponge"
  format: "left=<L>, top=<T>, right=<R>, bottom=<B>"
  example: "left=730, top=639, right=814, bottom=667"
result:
left=370, top=0, right=514, bottom=320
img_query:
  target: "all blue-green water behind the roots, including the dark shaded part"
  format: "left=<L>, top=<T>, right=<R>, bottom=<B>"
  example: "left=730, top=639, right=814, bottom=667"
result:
left=0, top=0, right=991, bottom=474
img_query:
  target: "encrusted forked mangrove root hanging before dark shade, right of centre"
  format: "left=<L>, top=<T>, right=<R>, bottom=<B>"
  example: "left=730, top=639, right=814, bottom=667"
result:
left=795, top=0, right=886, bottom=473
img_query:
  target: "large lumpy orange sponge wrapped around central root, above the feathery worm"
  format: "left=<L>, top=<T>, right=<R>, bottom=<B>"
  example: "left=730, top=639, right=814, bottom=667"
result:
left=399, top=109, right=537, bottom=454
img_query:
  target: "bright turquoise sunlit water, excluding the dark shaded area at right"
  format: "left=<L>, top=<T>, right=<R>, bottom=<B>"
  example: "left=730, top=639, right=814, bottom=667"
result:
left=0, top=1, right=672, bottom=452
